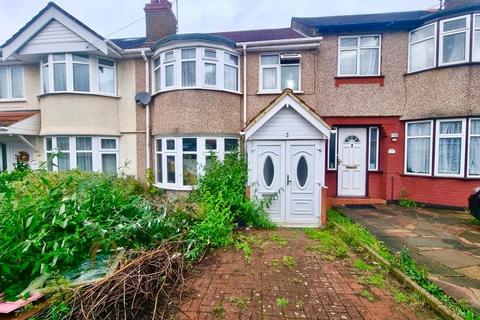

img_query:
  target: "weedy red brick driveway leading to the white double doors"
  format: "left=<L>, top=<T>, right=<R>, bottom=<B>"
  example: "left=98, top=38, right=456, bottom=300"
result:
left=177, top=229, right=433, bottom=319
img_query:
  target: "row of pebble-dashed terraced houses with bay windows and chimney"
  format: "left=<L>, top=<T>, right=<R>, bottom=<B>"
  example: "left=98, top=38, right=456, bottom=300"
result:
left=0, top=0, right=480, bottom=226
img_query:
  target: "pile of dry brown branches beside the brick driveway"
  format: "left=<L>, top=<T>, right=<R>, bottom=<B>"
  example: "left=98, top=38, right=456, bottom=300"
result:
left=67, top=242, right=184, bottom=320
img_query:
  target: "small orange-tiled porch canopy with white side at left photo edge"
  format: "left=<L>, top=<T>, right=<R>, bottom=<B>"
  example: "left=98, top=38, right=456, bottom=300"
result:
left=0, top=111, right=40, bottom=136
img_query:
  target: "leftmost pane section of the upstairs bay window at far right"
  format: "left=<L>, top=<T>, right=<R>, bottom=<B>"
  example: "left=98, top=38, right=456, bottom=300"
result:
left=408, top=23, right=437, bottom=72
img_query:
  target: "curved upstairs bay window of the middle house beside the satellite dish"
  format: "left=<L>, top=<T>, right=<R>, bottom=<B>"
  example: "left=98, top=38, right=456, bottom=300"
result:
left=153, top=47, right=239, bottom=92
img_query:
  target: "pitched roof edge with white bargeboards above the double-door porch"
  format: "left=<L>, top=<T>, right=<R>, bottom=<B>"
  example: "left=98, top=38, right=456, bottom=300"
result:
left=241, top=89, right=331, bottom=140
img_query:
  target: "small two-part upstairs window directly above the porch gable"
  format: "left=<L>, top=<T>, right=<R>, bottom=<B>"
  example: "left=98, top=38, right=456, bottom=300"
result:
left=260, top=54, right=301, bottom=92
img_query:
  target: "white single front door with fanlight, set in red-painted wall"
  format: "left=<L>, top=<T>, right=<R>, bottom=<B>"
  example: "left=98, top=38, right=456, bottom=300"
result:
left=338, top=128, right=367, bottom=197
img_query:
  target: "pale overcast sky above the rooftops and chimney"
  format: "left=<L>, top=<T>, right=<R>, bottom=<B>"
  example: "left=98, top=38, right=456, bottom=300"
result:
left=0, top=0, right=438, bottom=43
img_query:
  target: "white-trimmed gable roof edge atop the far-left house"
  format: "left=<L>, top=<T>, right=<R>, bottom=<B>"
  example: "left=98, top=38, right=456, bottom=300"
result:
left=0, top=2, right=107, bottom=60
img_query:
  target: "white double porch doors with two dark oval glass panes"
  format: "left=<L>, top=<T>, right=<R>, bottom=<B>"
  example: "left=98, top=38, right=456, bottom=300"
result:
left=249, top=140, right=325, bottom=226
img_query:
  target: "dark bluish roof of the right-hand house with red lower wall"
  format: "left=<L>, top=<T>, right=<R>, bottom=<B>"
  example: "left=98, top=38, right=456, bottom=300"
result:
left=292, top=10, right=432, bottom=31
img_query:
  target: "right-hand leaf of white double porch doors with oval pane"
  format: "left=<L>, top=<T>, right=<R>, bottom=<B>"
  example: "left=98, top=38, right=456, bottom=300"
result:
left=285, top=141, right=323, bottom=225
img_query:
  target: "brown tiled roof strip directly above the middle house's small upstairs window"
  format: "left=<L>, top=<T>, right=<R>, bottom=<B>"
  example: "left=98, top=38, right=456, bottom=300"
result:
left=211, top=28, right=305, bottom=42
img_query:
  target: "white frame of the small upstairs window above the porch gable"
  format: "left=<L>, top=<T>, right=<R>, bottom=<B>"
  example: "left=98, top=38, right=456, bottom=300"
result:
left=258, top=52, right=303, bottom=94
